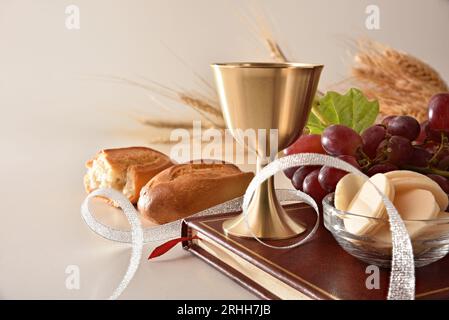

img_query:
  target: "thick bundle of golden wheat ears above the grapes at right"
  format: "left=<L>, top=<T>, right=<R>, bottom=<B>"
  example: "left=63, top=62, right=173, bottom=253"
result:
left=350, top=39, right=448, bottom=121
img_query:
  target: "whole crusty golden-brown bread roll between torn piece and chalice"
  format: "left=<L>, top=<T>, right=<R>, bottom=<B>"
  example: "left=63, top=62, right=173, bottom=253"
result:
left=137, top=162, right=254, bottom=224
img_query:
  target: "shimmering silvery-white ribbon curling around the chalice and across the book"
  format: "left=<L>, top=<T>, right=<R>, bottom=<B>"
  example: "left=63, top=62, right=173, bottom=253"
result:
left=81, top=153, right=415, bottom=300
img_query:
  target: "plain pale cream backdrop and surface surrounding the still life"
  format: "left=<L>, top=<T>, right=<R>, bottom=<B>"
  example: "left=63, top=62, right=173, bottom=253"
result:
left=0, top=0, right=449, bottom=299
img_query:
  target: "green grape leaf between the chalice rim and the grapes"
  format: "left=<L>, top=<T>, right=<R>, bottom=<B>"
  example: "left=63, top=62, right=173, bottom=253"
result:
left=306, top=88, right=379, bottom=134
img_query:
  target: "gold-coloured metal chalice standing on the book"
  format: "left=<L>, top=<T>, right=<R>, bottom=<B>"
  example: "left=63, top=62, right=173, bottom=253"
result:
left=212, top=63, right=323, bottom=240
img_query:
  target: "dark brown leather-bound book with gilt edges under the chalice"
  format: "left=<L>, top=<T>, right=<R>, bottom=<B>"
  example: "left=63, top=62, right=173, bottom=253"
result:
left=182, top=204, right=449, bottom=300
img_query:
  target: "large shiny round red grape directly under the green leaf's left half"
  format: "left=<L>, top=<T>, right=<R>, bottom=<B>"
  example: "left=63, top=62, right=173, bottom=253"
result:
left=321, top=124, right=363, bottom=156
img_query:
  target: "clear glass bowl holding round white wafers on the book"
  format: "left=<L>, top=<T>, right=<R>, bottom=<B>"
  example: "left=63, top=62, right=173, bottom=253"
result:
left=323, top=193, right=449, bottom=268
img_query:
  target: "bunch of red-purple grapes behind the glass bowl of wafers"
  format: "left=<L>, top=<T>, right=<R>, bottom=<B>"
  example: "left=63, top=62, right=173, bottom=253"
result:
left=284, top=93, right=449, bottom=203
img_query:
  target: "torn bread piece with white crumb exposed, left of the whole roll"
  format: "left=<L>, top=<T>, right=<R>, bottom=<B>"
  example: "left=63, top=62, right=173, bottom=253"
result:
left=84, top=147, right=173, bottom=204
